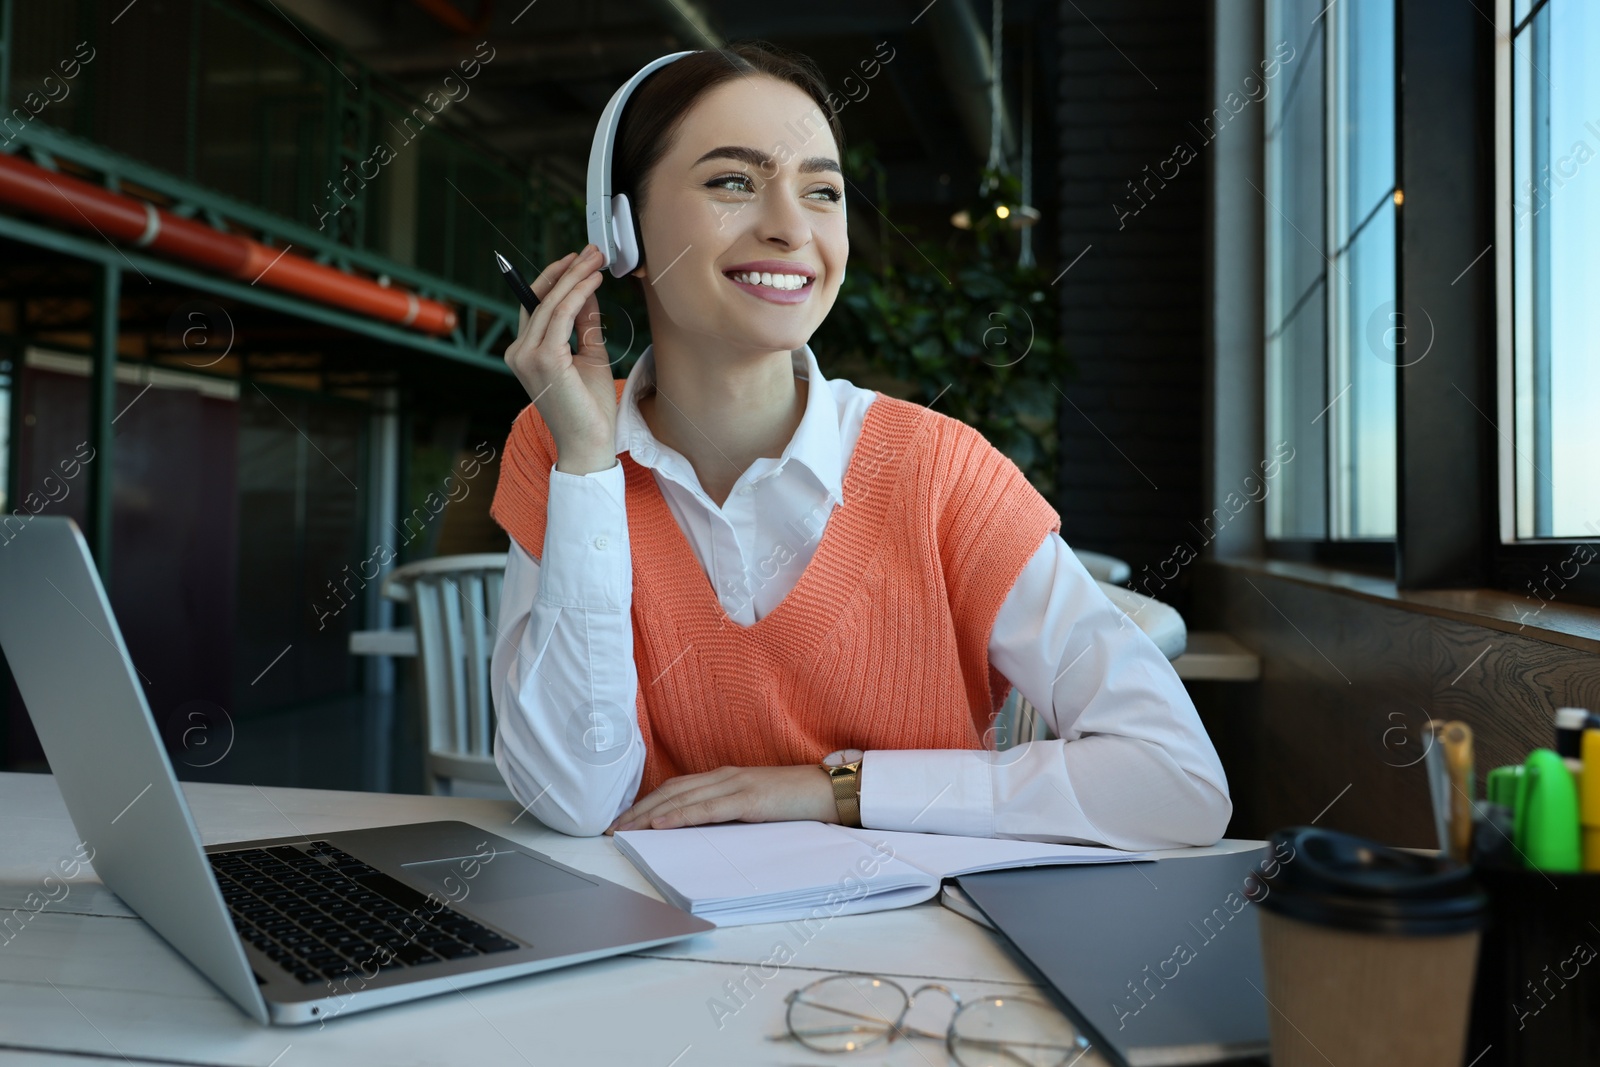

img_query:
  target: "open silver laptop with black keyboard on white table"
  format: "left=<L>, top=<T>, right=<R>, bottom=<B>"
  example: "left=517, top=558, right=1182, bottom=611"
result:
left=0, top=517, right=715, bottom=1024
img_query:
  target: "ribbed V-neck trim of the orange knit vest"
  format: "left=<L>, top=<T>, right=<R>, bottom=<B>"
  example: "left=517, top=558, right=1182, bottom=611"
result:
left=627, top=390, right=926, bottom=640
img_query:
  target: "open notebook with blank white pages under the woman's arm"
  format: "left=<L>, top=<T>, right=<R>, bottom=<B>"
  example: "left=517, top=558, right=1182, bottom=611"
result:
left=613, top=821, right=1149, bottom=926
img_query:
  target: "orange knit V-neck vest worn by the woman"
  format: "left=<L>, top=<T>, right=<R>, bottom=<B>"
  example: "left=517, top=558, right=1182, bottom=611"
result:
left=490, top=379, right=1061, bottom=797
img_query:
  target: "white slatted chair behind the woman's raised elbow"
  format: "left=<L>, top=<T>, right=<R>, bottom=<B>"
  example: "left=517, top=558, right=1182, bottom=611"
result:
left=372, top=552, right=510, bottom=798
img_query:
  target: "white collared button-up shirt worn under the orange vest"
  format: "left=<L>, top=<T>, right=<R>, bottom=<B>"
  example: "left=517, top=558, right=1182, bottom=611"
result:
left=490, top=346, right=1234, bottom=849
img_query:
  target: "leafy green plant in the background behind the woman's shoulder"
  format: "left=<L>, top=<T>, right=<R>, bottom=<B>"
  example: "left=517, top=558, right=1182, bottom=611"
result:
left=811, top=146, right=1070, bottom=498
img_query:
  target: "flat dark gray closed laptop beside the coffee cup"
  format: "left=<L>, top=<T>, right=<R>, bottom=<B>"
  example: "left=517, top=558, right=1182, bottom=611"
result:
left=958, top=848, right=1272, bottom=1067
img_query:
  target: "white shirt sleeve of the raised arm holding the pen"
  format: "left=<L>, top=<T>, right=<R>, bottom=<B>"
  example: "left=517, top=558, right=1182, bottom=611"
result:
left=490, top=462, right=645, bottom=837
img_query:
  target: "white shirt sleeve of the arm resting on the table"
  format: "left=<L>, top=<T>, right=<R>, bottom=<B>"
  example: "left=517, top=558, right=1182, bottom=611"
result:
left=861, top=533, right=1234, bottom=849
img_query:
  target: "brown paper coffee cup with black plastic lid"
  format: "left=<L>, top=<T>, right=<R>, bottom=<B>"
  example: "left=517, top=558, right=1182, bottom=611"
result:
left=1251, top=827, right=1488, bottom=1067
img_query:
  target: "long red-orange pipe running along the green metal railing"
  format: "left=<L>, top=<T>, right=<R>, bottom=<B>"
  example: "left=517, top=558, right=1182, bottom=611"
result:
left=0, top=154, right=456, bottom=334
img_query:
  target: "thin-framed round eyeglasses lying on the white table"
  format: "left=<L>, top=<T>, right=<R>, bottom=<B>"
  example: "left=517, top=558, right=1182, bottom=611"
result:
left=773, top=974, right=1091, bottom=1067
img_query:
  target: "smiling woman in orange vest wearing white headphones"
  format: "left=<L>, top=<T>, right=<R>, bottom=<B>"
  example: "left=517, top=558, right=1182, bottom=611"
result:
left=491, top=42, right=1232, bottom=849
